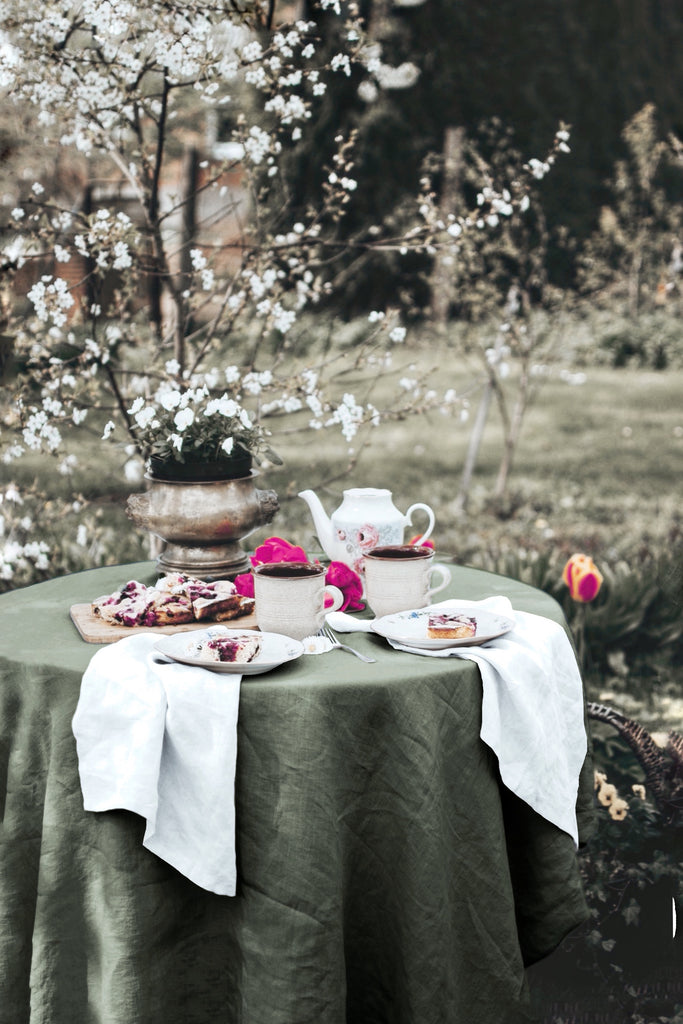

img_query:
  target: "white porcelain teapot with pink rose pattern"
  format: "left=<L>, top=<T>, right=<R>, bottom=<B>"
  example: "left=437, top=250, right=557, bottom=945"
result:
left=299, top=487, right=434, bottom=572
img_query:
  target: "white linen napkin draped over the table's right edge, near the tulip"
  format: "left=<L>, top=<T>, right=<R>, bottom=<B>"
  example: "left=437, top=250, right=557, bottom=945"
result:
left=390, top=597, right=587, bottom=846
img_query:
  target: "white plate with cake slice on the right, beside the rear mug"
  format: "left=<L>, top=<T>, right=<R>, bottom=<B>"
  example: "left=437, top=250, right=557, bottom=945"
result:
left=372, top=602, right=515, bottom=650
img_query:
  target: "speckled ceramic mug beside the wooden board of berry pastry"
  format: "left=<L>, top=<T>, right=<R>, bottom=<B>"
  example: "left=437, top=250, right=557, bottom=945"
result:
left=254, top=562, right=344, bottom=640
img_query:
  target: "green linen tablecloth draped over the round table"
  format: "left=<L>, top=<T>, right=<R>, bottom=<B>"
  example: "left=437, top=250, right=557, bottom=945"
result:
left=0, top=563, right=592, bottom=1024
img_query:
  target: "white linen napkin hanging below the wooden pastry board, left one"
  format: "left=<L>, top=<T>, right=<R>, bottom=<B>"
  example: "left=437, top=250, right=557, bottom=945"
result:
left=73, top=633, right=242, bottom=896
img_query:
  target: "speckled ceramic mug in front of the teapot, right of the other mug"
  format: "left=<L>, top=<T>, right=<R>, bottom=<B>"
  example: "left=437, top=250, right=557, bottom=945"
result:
left=366, top=544, right=451, bottom=618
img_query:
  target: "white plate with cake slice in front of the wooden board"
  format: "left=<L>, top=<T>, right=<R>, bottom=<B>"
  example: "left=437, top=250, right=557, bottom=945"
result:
left=155, top=626, right=303, bottom=676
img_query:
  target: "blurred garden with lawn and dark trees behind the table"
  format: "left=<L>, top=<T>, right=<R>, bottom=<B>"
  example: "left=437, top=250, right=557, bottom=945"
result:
left=0, top=0, right=683, bottom=1024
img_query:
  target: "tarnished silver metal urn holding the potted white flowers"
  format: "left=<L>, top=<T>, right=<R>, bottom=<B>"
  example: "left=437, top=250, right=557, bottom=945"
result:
left=126, top=470, right=280, bottom=580
